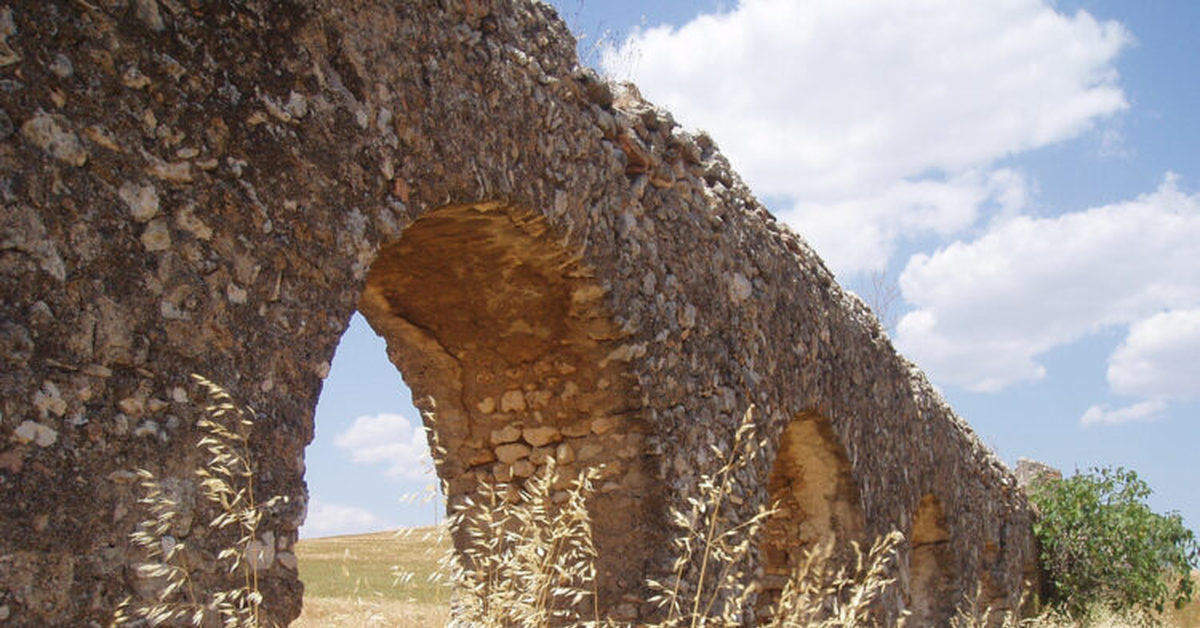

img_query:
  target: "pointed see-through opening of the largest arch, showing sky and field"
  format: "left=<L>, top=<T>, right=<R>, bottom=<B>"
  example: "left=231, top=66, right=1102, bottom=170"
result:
left=294, top=313, right=449, bottom=626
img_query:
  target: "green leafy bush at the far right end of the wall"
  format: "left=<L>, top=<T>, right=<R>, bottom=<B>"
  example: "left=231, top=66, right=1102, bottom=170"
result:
left=1030, top=467, right=1200, bottom=618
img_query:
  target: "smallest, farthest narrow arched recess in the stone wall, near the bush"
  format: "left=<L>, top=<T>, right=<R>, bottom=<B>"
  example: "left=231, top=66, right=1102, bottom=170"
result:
left=907, top=495, right=961, bottom=626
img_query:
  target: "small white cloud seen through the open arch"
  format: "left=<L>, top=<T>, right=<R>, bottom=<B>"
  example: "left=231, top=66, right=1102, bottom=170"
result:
left=334, top=413, right=433, bottom=480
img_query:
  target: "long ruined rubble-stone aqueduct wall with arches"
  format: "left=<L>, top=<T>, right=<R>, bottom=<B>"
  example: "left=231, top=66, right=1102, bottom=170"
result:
left=0, top=0, right=1033, bottom=626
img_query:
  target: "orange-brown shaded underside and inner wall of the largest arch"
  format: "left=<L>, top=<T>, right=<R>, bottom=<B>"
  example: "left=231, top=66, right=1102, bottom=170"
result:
left=359, top=203, right=662, bottom=609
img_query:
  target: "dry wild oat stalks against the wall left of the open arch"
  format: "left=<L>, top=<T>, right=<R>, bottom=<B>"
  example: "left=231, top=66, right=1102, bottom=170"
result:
left=113, top=375, right=287, bottom=628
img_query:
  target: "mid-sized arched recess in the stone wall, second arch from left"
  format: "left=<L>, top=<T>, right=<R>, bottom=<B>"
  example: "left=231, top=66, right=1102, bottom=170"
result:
left=758, top=412, right=866, bottom=609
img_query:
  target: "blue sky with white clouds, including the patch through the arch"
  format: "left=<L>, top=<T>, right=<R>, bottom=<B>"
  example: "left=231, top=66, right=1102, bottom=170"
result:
left=295, top=0, right=1200, bottom=537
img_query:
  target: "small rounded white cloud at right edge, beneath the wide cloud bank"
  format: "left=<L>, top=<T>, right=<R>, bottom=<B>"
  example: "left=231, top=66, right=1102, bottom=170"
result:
left=1108, top=307, right=1200, bottom=399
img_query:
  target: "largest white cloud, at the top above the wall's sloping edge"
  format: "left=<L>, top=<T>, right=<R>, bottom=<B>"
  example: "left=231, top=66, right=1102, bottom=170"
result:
left=602, top=0, right=1130, bottom=273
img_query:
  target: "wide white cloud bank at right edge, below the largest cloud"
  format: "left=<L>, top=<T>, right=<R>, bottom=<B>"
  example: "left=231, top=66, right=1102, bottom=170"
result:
left=896, top=174, right=1200, bottom=393
